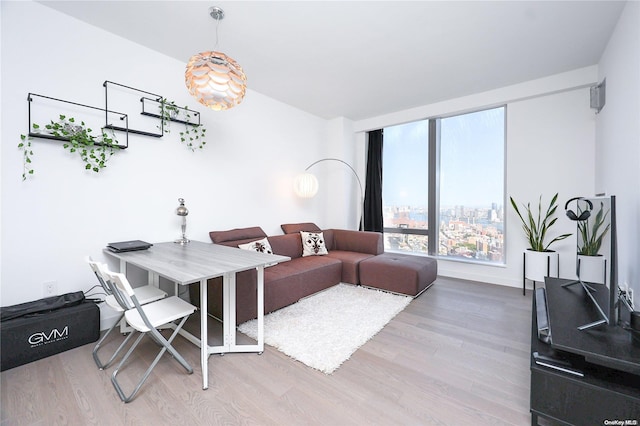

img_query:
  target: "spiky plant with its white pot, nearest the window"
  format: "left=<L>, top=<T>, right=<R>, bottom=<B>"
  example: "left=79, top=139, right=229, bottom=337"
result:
left=509, top=193, right=571, bottom=292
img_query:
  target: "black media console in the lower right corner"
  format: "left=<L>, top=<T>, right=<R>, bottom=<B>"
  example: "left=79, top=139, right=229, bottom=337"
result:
left=531, top=278, right=640, bottom=426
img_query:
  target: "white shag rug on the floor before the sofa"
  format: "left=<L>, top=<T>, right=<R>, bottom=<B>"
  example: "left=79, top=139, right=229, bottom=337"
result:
left=238, top=284, right=412, bottom=374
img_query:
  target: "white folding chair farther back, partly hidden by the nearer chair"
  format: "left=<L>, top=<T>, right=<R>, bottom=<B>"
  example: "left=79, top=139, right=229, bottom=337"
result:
left=85, top=256, right=167, bottom=370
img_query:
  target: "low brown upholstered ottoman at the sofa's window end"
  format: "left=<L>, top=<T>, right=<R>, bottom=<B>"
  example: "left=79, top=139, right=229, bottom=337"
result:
left=360, top=252, right=438, bottom=297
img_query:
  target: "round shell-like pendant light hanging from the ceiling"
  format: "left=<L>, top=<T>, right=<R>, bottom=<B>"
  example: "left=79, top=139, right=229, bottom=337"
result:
left=184, top=6, right=247, bottom=111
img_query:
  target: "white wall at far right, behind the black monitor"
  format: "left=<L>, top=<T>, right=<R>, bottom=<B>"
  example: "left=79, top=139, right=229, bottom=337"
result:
left=595, top=2, right=640, bottom=309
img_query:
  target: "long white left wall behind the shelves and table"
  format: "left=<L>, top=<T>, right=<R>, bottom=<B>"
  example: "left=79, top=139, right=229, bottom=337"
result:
left=0, top=2, right=350, bottom=316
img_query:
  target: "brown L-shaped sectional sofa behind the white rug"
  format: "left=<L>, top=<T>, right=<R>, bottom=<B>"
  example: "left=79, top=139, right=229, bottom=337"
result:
left=189, top=223, right=437, bottom=324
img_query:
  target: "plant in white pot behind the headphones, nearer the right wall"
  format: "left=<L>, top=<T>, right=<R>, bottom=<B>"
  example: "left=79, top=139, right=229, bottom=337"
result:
left=577, top=201, right=611, bottom=284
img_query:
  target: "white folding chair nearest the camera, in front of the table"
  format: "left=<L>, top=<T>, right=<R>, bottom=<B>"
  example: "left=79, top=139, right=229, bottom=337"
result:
left=103, top=270, right=196, bottom=402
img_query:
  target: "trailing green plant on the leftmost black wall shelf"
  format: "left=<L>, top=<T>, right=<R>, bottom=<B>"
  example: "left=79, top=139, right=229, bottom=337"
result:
left=18, top=114, right=120, bottom=180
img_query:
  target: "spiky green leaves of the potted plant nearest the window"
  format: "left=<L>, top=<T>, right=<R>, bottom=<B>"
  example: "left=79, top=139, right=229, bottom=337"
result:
left=509, top=193, right=571, bottom=251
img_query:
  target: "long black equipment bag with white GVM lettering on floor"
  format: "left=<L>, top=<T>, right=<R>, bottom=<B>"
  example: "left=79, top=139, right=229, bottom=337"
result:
left=0, top=292, right=100, bottom=371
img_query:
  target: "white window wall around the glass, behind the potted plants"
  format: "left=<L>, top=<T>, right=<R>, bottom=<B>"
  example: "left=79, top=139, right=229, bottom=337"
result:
left=354, top=66, right=597, bottom=287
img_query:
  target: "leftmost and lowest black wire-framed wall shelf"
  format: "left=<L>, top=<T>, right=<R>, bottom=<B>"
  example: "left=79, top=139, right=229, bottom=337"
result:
left=27, top=93, right=129, bottom=149
